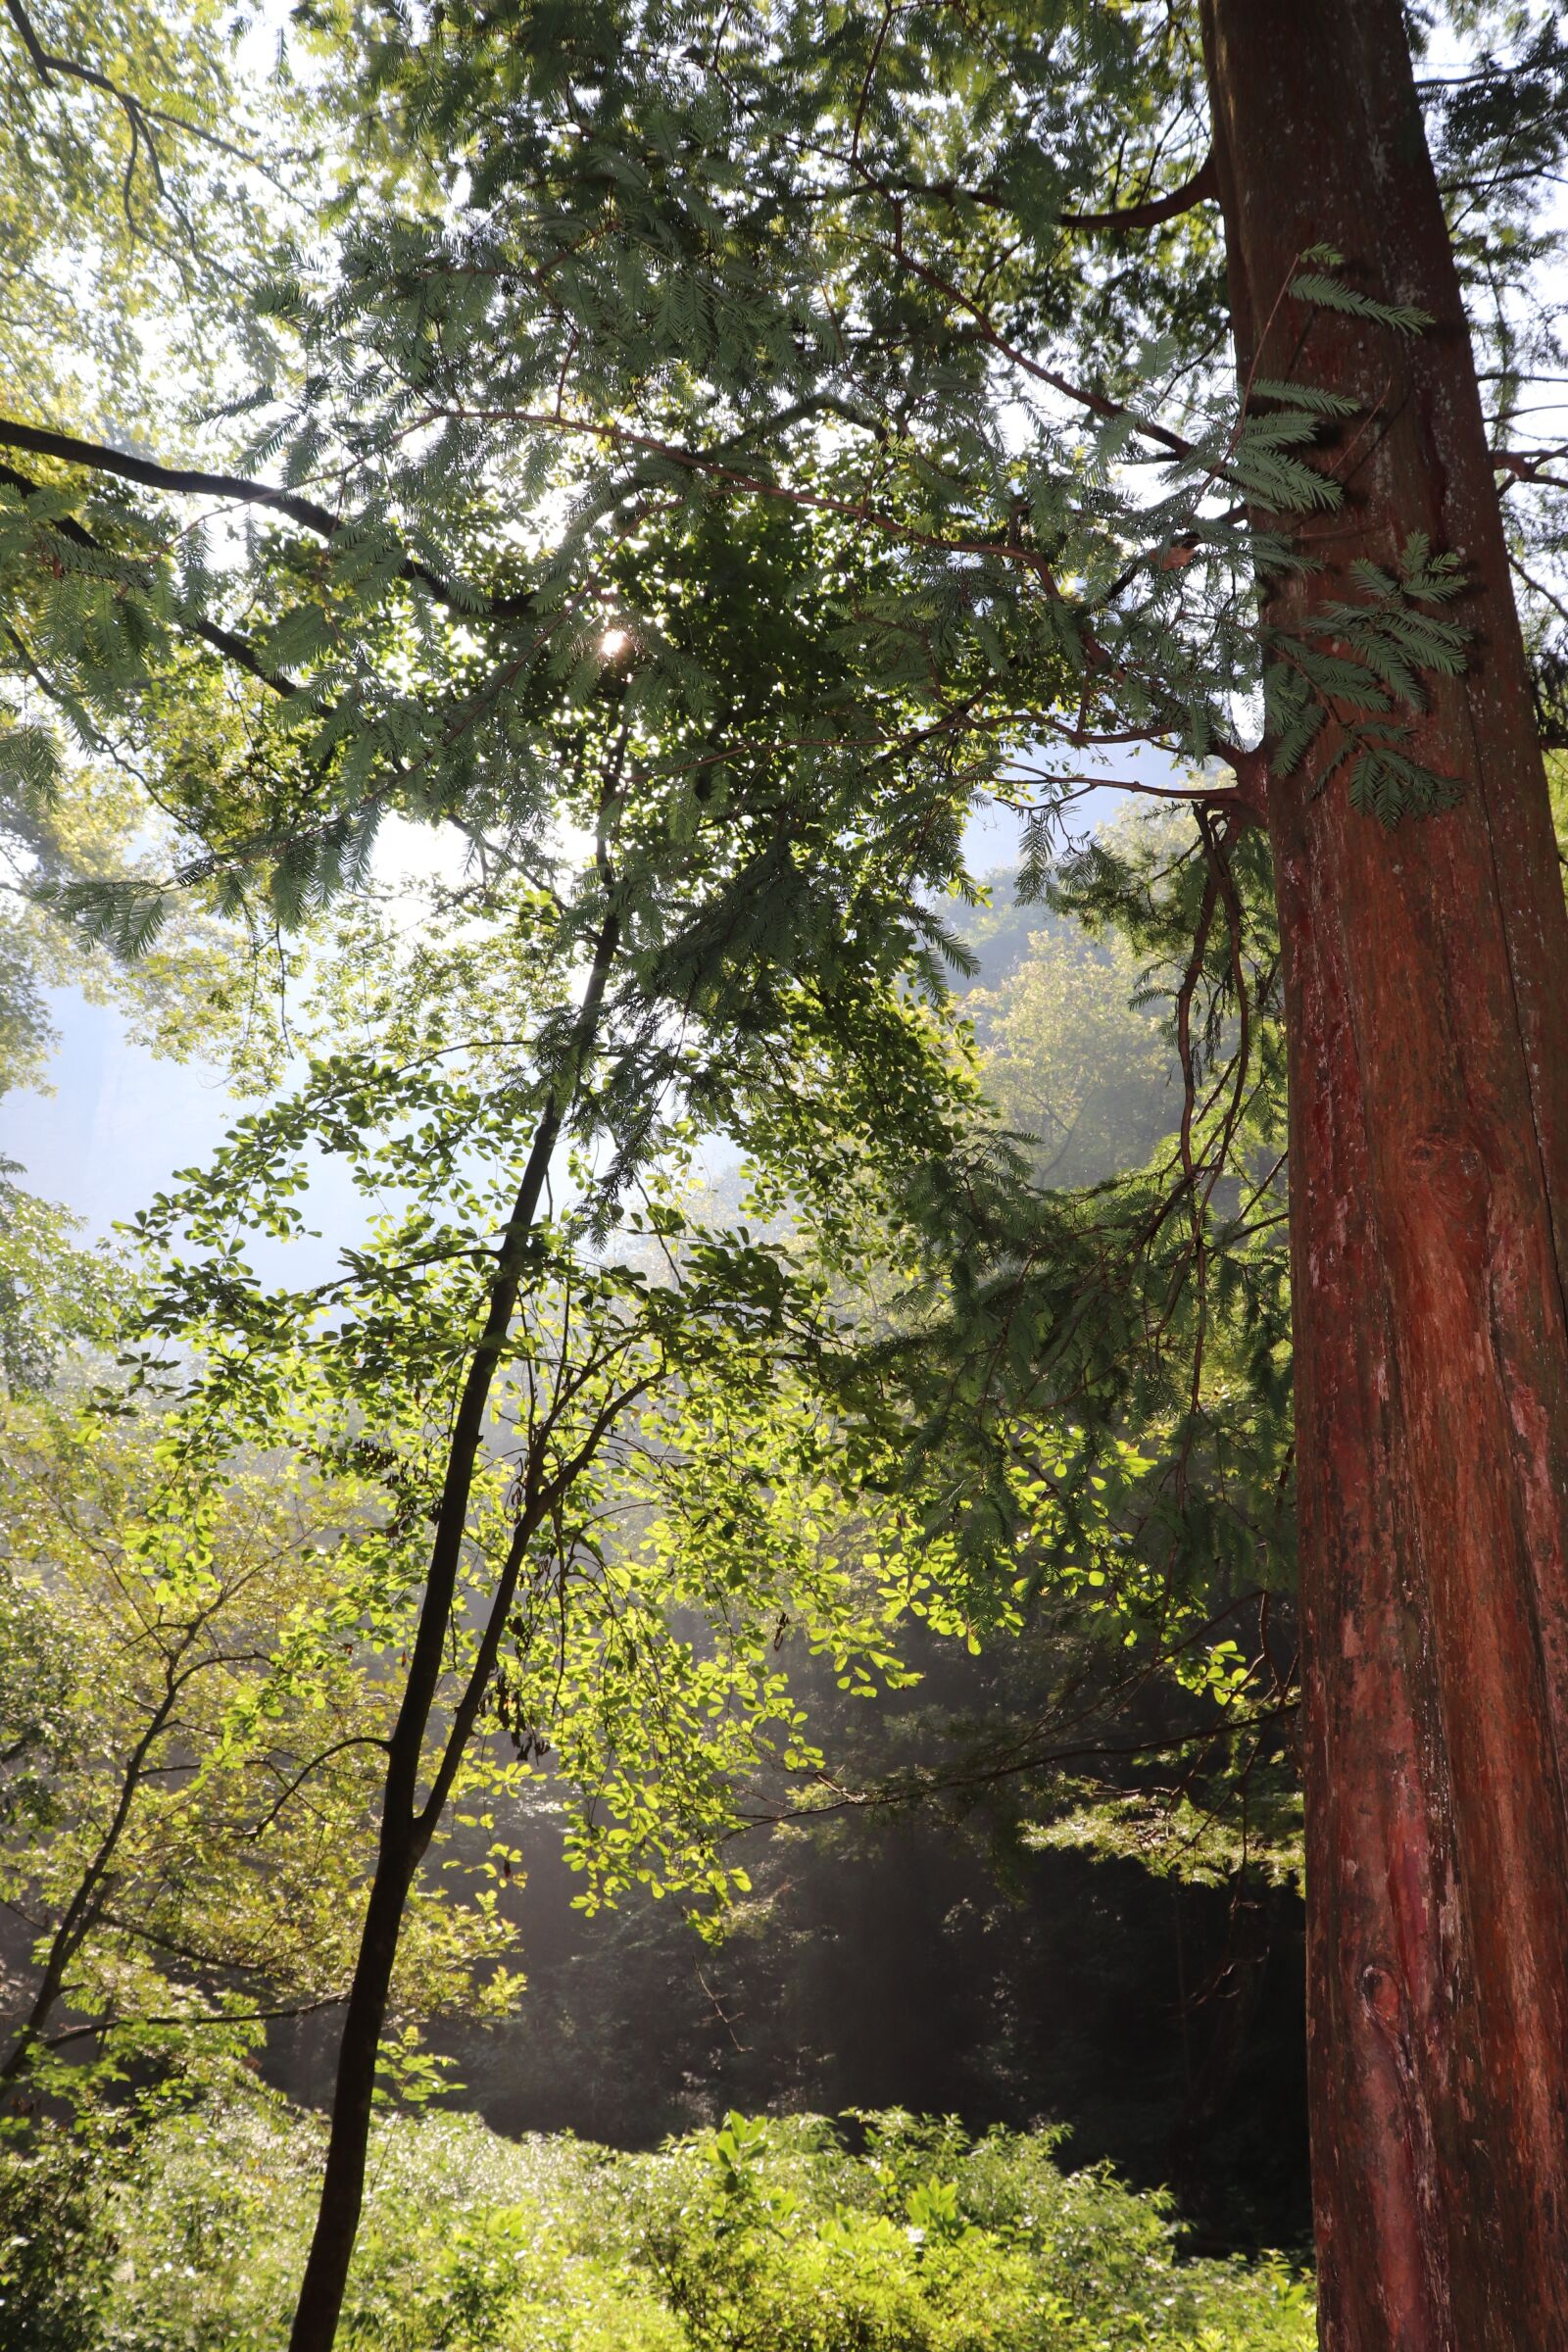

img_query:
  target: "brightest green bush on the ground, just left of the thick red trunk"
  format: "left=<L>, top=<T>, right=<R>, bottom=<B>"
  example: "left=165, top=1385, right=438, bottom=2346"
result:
left=632, top=2112, right=1314, bottom=2352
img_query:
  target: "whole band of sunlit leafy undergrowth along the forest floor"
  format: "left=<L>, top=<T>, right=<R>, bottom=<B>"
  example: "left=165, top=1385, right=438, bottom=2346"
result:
left=0, top=2107, right=1314, bottom=2352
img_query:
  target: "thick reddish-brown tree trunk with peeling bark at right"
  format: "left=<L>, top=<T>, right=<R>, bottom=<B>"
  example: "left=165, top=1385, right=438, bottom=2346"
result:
left=1203, top=0, right=1568, bottom=2352
